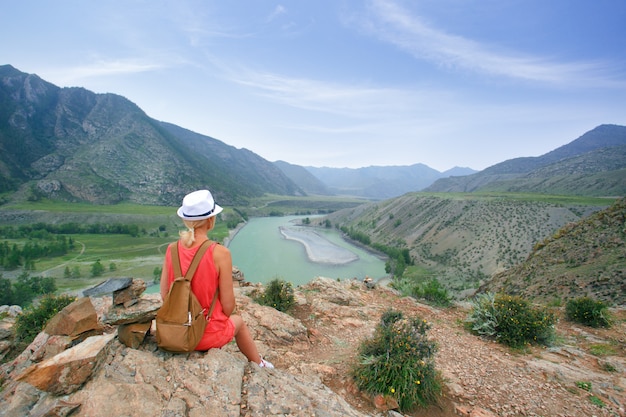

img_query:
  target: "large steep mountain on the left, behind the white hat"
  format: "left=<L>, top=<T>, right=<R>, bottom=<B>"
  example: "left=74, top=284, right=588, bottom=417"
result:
left=0, top=65, right=303, bottom=205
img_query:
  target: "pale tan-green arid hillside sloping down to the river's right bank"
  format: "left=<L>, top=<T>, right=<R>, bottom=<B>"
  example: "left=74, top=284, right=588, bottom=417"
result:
left=328, top=193, right=612, bottom=294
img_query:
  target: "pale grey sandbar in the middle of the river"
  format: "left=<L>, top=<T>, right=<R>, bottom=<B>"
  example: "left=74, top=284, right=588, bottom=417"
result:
left=278, top=226, right=359, bottom=265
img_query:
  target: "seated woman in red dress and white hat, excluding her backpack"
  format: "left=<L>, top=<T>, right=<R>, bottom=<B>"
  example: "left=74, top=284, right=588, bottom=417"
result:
left=161, top=190, right=274, bottom=368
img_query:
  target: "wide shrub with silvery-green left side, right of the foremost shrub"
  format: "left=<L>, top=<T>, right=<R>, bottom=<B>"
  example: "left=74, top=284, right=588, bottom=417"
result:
left=466, top=294, right=556, bottom=348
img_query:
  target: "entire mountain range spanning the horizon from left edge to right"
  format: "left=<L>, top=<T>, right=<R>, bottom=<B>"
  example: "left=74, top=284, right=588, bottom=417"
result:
left=0, top=65, right=626, bottom=205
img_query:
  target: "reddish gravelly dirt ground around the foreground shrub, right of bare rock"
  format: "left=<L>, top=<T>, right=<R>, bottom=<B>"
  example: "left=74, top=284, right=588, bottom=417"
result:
left=272, top=282, right=626, bottom=417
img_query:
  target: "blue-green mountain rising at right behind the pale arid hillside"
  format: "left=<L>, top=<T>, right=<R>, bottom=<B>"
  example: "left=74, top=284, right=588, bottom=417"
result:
left=425, top=125, right=626, bottom=196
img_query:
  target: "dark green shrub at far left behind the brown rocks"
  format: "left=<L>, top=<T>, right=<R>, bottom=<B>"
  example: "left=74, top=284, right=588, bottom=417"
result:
left=15, top=295, right=76, bottom=345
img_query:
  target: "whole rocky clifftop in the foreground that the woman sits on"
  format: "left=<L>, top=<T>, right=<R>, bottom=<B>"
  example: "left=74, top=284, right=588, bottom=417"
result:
left=0, top=278, right=626, bottom=417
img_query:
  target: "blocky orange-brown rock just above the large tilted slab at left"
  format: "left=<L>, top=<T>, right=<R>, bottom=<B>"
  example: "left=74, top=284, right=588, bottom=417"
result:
left=44, top=297, right=102, bottom=339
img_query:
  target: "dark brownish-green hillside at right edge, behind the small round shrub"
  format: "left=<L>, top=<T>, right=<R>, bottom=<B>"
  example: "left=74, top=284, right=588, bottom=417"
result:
left=481, top=198, right=626, bottom=305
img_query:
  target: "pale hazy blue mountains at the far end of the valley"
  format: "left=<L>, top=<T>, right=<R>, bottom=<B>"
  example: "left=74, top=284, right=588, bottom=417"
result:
left=302, top=164, right=476, bottom=200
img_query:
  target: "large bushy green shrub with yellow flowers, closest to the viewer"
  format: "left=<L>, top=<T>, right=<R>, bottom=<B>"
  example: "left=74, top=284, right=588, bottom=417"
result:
left=352, top=310, right=442, bottom=411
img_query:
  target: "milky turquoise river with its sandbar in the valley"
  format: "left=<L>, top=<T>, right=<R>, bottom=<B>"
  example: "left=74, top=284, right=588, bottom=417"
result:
left=228, top=216, right=387, bottom=285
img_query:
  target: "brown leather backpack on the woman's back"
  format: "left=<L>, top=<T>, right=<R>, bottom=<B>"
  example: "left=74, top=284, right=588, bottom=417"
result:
left=156, top=240, right=219, bottom=353
